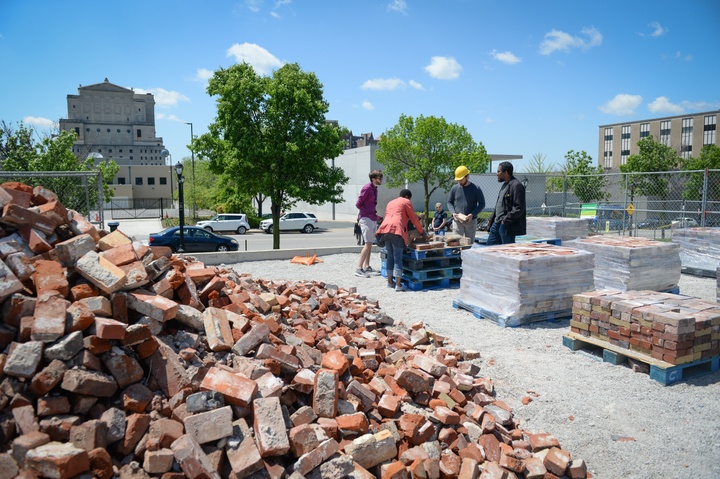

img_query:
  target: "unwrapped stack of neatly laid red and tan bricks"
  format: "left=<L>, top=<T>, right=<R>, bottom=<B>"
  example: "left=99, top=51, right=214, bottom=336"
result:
left=570, top=290, right=720, bottom=364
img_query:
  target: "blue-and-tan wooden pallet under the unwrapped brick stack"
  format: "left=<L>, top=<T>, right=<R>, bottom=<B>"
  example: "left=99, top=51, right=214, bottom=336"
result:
left=562, top=333, right=720, bottom=386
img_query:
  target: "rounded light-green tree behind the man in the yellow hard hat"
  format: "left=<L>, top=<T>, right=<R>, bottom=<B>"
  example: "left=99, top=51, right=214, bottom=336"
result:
left=377, top=115, right=490, bottom=228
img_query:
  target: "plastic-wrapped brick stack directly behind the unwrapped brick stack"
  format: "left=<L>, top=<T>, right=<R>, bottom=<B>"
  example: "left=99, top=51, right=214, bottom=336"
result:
left=565, top=236, right=680, bottom=292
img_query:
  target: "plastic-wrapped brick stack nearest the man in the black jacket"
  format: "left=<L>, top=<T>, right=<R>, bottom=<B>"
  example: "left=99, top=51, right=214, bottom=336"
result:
left=458, top=243, right=593, bottom=326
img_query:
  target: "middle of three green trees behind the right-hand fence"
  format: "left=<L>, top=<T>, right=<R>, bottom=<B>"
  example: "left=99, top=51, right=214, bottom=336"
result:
left=620, top=136, right=681, bottom=203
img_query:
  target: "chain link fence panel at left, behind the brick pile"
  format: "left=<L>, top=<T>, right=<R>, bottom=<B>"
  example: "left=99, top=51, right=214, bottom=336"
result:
left=0, top=171, right=105, bottom=228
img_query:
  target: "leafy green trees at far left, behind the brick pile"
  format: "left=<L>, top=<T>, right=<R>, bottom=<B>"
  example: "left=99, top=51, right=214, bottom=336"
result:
left=0, top=122, right=120, bottom=214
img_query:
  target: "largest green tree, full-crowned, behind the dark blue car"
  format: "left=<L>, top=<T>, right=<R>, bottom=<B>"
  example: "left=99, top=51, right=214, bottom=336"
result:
left=194, top=63, right=348, bottom=249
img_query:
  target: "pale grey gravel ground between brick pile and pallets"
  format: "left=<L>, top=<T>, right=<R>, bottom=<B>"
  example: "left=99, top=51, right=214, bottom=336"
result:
left=229, top=254, right=720, bottom=479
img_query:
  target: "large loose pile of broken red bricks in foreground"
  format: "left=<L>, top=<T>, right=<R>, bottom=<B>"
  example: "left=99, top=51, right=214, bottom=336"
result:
left=0, top=183, right=589, bottom=479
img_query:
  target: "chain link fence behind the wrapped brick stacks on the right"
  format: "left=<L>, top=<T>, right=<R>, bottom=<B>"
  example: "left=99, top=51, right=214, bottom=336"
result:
left=516, top=170, right=720, bottom=238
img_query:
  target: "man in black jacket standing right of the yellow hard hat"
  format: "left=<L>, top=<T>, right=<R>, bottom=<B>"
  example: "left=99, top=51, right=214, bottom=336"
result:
left=486, top=161, right=527, bottom=246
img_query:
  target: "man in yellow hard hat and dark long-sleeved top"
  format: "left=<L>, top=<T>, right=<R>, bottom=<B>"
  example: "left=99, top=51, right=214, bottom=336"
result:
left=448, top=166, right=485, bottom=241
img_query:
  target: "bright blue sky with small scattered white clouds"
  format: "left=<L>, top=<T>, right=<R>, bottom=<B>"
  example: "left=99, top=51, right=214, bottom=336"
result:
left=0, top=0, right=720, bottom=170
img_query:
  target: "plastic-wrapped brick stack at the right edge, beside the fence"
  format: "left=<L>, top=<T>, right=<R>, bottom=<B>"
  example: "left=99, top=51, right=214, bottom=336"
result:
left=673, top=228, right=720, bottom=276
